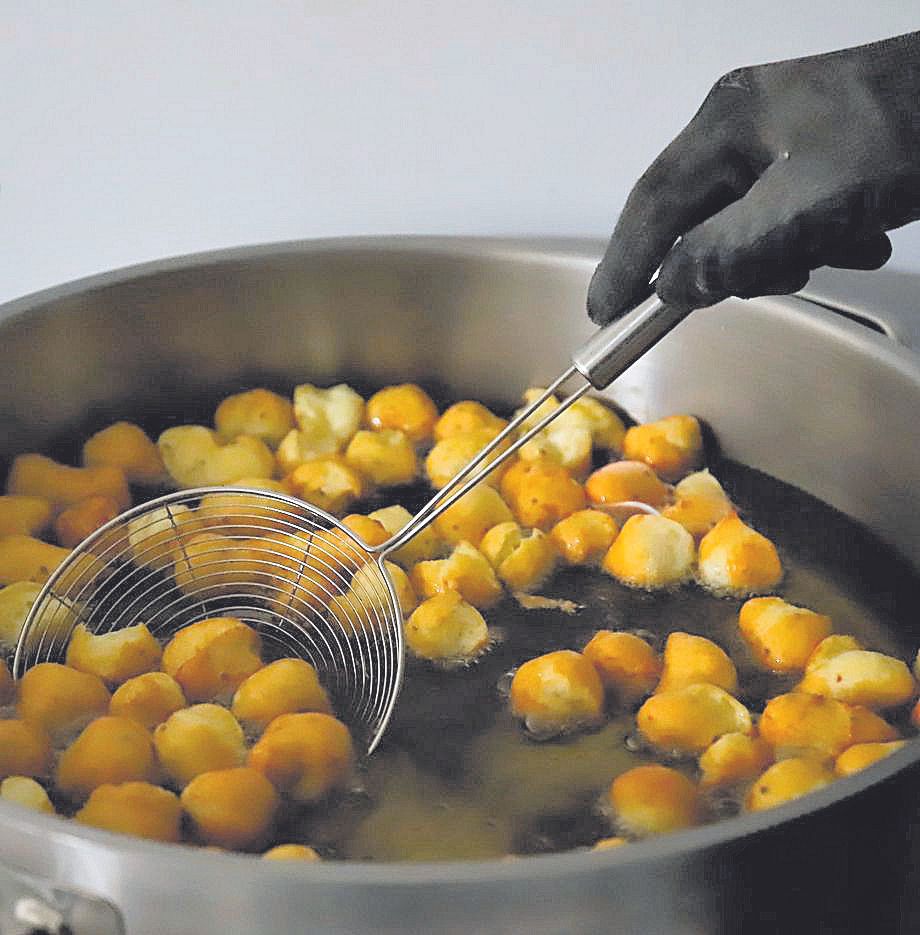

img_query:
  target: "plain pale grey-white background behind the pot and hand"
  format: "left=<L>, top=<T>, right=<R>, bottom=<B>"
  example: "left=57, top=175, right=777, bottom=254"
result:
left=0, top=0, right=920, bottom=299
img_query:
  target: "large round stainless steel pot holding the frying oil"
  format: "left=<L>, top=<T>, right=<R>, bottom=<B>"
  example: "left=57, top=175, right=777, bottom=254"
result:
left=0, top=239, right=920, bottom=935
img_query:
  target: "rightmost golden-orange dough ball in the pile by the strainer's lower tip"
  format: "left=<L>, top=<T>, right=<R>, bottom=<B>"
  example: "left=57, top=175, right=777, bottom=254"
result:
left=248, top=712, right=354, bottom=803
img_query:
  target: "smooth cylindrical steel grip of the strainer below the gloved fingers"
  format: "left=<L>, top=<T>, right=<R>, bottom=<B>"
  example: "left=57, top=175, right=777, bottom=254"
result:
left=572, top=293, right=690, bottom=390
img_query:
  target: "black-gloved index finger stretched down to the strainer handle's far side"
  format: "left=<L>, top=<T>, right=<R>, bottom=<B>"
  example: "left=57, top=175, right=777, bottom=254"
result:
left=588, top=124, right=756, bottom=325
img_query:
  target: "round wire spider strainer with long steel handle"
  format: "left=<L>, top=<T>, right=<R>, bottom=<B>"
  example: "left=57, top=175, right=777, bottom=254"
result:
left=13, top=296, right=686, bottom=753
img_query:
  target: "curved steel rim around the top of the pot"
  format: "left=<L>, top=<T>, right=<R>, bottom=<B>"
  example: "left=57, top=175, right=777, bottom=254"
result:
left=0, top=235, right=920, bottom=889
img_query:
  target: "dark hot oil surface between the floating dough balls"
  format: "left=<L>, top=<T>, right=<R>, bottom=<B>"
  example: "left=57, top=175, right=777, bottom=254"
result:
left=27, top=390, right=920, bottom=861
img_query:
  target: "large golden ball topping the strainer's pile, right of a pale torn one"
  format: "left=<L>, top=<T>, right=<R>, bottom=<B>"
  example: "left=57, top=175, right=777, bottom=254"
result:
left=162, top=617, right=262, bottom=701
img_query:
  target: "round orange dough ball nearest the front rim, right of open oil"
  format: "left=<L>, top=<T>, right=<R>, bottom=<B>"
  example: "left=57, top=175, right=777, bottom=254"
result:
left=607, top=764, right=702, bottom=835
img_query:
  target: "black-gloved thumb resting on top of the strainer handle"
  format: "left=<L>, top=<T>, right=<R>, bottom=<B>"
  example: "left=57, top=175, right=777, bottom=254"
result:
left=656, top=160, right=864, bottom=309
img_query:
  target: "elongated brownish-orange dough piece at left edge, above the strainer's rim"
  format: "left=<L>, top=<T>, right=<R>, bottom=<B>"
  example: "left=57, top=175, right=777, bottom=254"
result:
left=6, top=454, right=131, bottom=510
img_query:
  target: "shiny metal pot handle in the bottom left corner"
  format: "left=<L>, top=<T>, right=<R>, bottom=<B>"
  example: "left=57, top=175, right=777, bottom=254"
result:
left=0, top=864, right=125, bottom=935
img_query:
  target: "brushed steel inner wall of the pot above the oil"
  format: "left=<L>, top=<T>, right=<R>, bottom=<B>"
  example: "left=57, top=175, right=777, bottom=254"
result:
left=0, top=240, right=920, bottom=564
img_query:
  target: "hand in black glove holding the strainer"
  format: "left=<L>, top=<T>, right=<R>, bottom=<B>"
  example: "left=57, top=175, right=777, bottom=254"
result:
left=588, top=32, right=920, bottom=324
